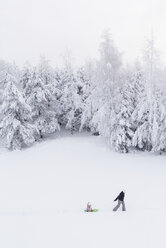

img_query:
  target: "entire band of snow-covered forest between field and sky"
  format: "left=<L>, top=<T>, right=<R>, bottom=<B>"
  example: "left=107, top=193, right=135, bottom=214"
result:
left=0, top=31, right=166, bottom=153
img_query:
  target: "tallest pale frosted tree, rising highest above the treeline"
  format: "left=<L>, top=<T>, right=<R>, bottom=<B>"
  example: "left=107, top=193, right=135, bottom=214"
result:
left=92, top=31, right=121, bottom=134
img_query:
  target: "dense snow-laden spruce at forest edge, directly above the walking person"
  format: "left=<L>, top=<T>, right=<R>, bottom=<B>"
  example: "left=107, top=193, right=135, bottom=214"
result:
left=109, top=85, right=134, bottom=152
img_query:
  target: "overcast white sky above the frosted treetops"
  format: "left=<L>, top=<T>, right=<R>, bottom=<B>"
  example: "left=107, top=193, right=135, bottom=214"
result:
left=0, top=0, right=166, bottom=65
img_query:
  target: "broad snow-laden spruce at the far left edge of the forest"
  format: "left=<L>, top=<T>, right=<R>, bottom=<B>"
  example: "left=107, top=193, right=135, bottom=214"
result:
left=0, top=75, right=37, bottom=149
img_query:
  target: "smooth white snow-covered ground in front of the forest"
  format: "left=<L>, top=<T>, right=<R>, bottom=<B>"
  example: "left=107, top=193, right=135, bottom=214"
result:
left=0, top=134, right=166, bottom=248
